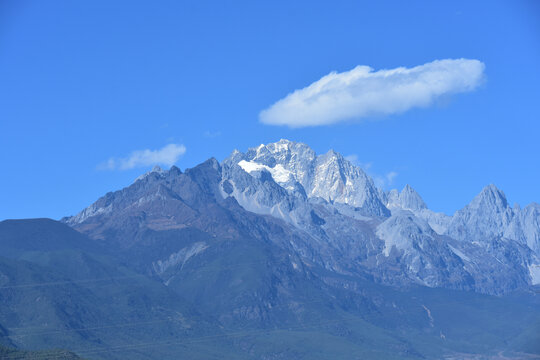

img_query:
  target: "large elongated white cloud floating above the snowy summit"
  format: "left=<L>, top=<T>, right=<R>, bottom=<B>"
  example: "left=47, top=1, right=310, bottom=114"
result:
left=259, top=59, right=485, bottom=128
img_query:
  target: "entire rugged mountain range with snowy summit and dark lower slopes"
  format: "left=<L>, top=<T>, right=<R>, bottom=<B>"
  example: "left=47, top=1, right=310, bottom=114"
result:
left=0, top=140, right=540, bottom=359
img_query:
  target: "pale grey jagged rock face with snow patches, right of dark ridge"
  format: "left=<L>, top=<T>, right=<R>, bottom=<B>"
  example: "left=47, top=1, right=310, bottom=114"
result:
left=219, top=140, right=538, bottom=293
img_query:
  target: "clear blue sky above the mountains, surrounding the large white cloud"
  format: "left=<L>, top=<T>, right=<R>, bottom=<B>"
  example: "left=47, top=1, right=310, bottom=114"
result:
left=0, top=0, right=540, bottom=219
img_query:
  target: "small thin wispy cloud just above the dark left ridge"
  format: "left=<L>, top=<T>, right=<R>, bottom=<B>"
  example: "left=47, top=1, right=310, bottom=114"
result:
left=98, top=144, right=186, bottom=170
